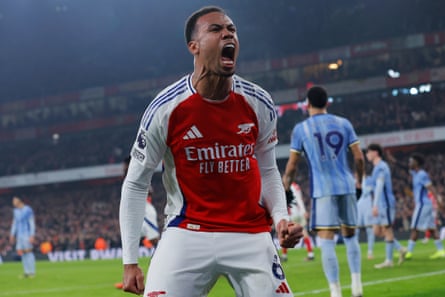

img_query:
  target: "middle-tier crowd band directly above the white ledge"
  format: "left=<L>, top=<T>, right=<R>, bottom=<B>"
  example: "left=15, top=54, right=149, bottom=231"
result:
left=0, top=86, right=445, bottom=176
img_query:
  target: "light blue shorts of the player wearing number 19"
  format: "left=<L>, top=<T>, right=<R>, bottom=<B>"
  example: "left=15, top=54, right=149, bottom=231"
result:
left=310, top=194, right=357, bottom=230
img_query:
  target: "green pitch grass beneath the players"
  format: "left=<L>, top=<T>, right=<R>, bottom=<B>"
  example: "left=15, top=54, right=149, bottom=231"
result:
left=0, top=241, right=445, bottom=297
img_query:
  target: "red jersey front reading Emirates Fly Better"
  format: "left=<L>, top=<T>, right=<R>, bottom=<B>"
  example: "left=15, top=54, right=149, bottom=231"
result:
left=167, top=92, right=271, bottom=232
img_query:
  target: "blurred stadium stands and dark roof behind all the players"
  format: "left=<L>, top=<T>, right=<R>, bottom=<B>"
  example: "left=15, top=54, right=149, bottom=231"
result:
left=0, top=0, right=445, bottom=259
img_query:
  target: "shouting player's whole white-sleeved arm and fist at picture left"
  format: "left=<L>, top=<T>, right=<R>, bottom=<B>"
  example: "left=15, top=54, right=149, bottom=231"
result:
left=119, top=100, right=167, bottom=295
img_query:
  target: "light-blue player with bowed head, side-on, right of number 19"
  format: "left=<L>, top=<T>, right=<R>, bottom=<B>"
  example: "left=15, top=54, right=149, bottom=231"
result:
left=366, top=143, right=407, bottom=269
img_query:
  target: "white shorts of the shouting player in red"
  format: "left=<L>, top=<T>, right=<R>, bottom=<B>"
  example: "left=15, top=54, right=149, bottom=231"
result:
left=143, top=227, right=294, bottom=297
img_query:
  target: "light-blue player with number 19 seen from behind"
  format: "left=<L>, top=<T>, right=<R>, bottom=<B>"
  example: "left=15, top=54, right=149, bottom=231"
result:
left=283, top=86, right=364, bottom=297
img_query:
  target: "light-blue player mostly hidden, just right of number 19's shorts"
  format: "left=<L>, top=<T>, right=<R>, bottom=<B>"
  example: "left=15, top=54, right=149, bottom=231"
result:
left=356, top=176, right=375, bottom=259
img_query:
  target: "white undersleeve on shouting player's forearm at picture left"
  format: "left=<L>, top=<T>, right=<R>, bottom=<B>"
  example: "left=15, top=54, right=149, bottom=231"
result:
left=119, top=159, right=155, bottom=264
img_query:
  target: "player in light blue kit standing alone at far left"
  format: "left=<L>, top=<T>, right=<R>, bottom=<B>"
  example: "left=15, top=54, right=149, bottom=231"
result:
left=10, top=196, right=36, bottom=278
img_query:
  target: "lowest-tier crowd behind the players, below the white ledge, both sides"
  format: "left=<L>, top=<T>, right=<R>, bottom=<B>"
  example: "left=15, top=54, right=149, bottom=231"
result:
left=0, top=142, right=445, bottom=256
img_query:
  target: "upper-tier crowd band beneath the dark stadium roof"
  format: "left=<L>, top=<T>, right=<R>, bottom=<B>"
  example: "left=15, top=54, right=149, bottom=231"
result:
left=0, top=45, right=445, bottom=129
